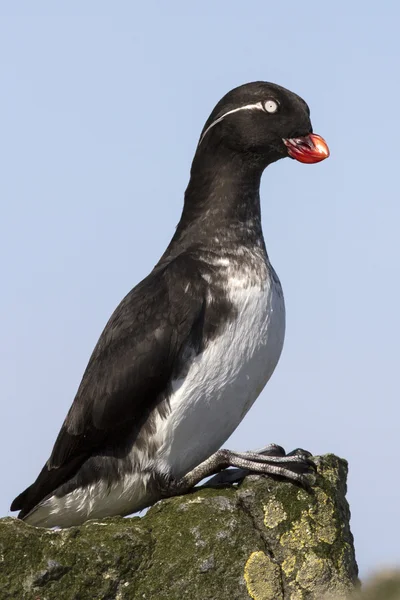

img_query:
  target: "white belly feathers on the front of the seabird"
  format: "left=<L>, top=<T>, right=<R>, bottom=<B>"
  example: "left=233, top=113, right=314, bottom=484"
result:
left=155, top=278, right=285, bottom=478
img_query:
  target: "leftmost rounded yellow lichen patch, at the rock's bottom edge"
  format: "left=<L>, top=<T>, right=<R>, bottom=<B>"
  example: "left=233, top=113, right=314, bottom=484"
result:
left=244, top=551, right=283, bottom=600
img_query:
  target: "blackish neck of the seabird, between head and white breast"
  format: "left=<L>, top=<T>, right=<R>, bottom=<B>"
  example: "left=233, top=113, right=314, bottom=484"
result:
left=167, top=149, right=264, bottom=254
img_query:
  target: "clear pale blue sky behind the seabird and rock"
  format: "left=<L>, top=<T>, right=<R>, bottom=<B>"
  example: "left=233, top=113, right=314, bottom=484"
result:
left=0, top=0, right=400, bottom=575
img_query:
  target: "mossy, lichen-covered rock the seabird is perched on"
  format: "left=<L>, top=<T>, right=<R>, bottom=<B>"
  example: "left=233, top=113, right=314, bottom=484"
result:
left=0, top=455, right=357, bottom=600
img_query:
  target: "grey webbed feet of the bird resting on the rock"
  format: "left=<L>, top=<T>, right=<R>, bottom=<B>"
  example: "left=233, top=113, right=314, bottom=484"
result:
left=167, top=444, right=316, bottom=496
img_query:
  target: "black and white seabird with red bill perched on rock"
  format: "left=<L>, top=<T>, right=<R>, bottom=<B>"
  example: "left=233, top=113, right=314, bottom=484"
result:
left=11, top=82, right=329, bottom=527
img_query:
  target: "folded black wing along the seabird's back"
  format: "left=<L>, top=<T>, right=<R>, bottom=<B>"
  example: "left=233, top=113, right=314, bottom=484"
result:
left=11, top=255, right=205, bottom=518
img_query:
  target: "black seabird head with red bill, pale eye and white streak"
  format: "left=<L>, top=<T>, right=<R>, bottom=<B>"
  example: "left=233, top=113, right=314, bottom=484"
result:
left=198, top=81, right=329, bottom=167
